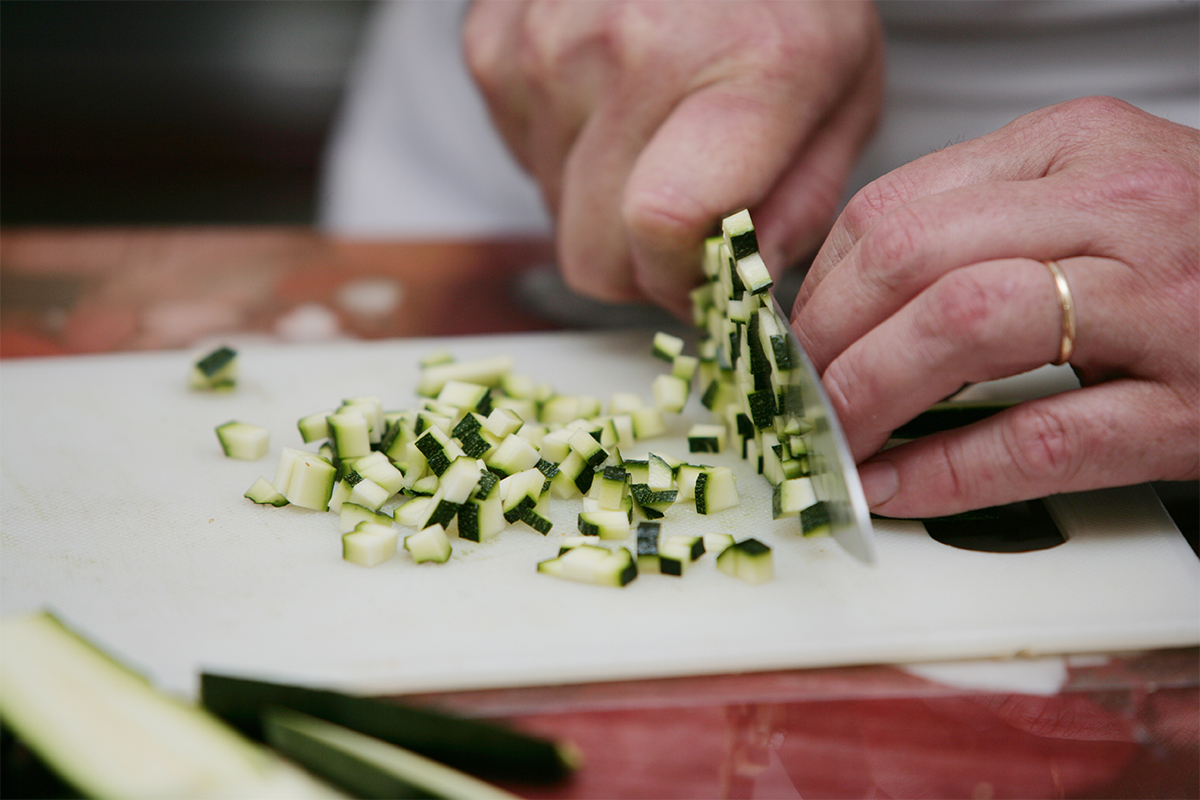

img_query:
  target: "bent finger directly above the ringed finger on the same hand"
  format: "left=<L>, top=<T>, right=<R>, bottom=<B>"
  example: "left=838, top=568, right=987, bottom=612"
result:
left=792, top=172, right=1111, bottom=372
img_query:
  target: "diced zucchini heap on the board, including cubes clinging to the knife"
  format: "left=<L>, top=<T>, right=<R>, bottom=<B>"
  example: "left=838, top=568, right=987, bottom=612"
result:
left=218, top=211, right=844, bottom=587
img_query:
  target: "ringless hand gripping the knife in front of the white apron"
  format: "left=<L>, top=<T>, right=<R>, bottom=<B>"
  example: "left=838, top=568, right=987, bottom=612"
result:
left=463, top=0, right=882, bottom=317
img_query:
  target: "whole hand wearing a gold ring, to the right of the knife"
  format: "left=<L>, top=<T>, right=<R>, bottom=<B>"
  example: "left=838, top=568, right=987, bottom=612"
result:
left=792, top=97, right=1200, bottom=517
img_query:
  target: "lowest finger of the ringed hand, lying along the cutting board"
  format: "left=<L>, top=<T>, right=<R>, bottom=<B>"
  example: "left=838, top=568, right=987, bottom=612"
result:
left=859, top=379, right=1200, bottom=517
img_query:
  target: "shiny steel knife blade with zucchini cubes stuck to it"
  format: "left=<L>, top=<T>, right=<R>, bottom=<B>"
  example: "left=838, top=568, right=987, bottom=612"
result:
left=696, top=209, right=876, bottom=564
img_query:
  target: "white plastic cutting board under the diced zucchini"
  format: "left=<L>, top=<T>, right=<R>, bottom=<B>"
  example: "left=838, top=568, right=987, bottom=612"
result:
left=0, top=332, right=1200, bottom=693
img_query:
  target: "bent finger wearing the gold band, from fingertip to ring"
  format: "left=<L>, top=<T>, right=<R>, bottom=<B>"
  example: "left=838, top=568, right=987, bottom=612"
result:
left=822, top=259, right=1070, bottom=461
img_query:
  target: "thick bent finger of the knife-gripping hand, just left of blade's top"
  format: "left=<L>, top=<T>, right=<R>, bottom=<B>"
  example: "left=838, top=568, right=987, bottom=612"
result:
left=622, top=84, right=844, bottom=315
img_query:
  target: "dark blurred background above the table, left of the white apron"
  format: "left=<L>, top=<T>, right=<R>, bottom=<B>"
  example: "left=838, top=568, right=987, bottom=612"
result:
left=0, top=0, right=371, bottom=225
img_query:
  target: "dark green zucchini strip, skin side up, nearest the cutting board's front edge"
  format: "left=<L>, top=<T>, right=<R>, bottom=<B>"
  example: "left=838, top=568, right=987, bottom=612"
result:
left=200, top=673, right=575, bottom=784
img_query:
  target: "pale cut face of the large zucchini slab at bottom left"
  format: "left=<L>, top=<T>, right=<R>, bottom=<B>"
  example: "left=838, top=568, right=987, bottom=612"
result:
left=0, top=614, right=338, bottom=799
